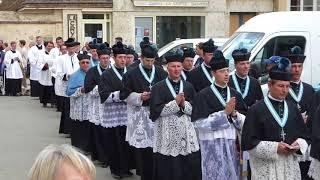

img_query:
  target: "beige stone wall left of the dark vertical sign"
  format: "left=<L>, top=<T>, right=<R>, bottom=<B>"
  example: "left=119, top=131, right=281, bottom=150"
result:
left=0, top=10, right=63, bottom=43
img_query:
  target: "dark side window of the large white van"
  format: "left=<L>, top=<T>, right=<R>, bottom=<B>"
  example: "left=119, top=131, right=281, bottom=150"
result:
left=251, top=36, right=306, bottom=84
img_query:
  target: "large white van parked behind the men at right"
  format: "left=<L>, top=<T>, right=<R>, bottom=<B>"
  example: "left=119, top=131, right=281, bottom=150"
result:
left=221, top=11, right=320, bottom=89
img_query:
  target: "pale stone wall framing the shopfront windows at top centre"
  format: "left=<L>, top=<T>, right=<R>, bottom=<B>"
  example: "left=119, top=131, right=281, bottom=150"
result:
left=112, top=0, right=274, bottom=44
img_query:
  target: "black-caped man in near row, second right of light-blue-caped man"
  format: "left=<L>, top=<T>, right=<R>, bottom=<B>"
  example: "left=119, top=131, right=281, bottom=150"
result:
left=98, top=42, right=132, bottom=179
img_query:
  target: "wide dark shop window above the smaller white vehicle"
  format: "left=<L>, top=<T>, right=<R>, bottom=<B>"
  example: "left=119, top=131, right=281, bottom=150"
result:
left=156, top=16, right=205, bottom=48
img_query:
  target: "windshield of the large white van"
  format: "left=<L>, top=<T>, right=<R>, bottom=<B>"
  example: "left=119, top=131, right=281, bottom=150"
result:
left=221, top=32, right=264, bottom=70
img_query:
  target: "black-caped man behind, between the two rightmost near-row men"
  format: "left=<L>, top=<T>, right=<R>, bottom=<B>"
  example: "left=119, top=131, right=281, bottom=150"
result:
left=229, top=49, right=263, bottom=108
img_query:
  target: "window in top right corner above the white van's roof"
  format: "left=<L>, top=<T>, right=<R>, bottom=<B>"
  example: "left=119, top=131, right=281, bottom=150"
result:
left=289, top=0, right=320, bottom=11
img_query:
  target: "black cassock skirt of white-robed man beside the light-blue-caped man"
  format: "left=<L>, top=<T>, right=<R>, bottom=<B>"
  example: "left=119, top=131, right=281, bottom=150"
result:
left=59, top=96, right=72, bottom=134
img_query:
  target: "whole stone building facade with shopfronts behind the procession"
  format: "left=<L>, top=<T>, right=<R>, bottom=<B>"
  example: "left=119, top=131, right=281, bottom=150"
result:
left=0, top=0, right=288, bottom=48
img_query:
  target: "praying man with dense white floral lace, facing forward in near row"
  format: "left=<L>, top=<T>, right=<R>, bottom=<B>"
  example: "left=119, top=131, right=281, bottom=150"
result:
left=150, top=49, right=201, bottom=180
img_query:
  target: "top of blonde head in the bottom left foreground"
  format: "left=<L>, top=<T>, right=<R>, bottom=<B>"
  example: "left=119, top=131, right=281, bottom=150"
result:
left=29, top=144, right=96, bottom=180
